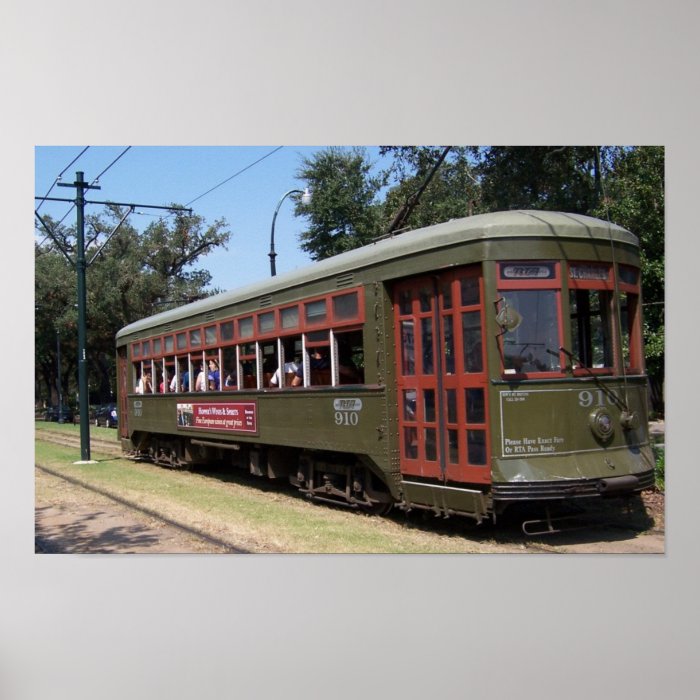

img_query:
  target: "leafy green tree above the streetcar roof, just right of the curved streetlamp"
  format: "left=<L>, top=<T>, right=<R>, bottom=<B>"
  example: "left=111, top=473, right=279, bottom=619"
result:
left=295, top=148, right=383, bottom=260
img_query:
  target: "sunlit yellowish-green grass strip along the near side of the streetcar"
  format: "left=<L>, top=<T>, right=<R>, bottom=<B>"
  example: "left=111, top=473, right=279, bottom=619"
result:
left=35, top=438, right=484, bottom=553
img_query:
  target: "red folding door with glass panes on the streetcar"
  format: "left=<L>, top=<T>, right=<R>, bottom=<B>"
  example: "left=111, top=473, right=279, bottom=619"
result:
left=394, top=265, right=491, bottom=483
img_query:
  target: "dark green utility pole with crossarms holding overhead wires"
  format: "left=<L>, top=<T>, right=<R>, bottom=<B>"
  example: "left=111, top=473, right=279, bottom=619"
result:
left=34, top=171, right=192, bottom=462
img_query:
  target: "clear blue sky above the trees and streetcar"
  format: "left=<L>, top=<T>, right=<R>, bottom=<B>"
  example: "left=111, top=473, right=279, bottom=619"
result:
left=35, top=145, right=388, bottom=290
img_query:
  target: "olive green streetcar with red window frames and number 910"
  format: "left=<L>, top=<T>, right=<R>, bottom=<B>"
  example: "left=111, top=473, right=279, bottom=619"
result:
left=116, top=211, right=654, bottom=522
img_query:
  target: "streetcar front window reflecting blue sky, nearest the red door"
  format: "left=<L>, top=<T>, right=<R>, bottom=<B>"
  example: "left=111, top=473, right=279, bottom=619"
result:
left=501, top=289, right=561, bottom=374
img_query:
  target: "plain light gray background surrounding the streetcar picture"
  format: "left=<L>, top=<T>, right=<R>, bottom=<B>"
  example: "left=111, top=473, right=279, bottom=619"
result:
left=0, top=0, right=700, bottom=700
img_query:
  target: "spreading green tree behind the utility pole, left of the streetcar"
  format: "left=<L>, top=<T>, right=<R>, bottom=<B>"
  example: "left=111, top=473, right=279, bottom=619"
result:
left=35, top=208, right=230, bottom=400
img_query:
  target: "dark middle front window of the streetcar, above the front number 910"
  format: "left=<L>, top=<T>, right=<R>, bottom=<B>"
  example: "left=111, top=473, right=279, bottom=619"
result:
left=569, top=289, right=613, bottom=368
